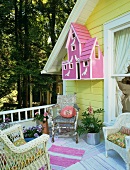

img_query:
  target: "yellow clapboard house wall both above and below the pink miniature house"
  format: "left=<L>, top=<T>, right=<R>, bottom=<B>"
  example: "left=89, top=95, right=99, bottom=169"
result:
left=66, top=0, right=130, bottom=119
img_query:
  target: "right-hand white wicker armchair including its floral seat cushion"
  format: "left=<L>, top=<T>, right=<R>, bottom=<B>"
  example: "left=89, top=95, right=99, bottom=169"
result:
left=103, top=113, right=130, bottom=170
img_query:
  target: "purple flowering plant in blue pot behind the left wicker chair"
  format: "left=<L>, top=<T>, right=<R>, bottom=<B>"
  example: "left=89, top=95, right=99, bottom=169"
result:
left=23, top=125, right=43, bottom=142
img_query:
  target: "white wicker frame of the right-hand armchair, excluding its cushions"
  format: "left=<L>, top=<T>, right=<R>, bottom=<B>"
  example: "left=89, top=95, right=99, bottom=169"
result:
left=103, top=113, right=130, bottom=170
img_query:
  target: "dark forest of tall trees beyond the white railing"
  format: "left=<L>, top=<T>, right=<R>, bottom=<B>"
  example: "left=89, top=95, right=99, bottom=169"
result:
left=0, top=0, right=76, bottom=110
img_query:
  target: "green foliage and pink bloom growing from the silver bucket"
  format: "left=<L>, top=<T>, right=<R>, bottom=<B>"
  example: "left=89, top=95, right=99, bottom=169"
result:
left=77, top=106, right=104, bottom=135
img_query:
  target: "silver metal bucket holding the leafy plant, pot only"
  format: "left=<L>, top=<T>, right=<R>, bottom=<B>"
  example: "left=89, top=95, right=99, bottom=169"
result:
left=86, top=133, right=100, bottom=145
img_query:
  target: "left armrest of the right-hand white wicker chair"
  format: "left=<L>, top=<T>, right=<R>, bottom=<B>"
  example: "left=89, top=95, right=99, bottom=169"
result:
left=103, top=126, right=120, bottom=140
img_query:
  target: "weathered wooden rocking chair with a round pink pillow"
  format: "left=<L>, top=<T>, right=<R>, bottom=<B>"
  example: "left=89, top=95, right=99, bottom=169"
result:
left=51, top=94, right=79, bottom=143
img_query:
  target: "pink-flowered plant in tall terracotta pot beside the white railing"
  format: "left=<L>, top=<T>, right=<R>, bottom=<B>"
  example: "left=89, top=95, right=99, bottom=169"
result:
left=34, top=111, right=49, bottom=134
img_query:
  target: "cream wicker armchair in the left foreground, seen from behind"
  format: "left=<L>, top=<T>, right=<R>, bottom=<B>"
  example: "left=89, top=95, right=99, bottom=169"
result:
left=0, top=125, right=51, bottom=170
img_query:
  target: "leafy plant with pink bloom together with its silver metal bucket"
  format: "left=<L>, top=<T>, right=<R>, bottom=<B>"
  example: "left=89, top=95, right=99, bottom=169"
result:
left=77, top=106, right=104, bottom=145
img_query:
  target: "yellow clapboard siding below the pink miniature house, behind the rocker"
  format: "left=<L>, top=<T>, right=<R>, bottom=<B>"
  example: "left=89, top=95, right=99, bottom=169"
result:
left=66, top=80, right=104, bottom=117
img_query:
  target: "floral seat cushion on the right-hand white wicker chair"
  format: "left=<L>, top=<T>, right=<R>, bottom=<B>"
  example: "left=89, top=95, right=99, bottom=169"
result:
left=107, top=132, right=128, bottom=148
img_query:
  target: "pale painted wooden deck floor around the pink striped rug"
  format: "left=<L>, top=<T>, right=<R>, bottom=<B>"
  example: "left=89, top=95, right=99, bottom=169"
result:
left=48, top=136, right=126, bottom=170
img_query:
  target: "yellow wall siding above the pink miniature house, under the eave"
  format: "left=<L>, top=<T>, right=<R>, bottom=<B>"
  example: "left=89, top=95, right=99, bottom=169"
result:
left=85, top=0, right=130, bottom=51
